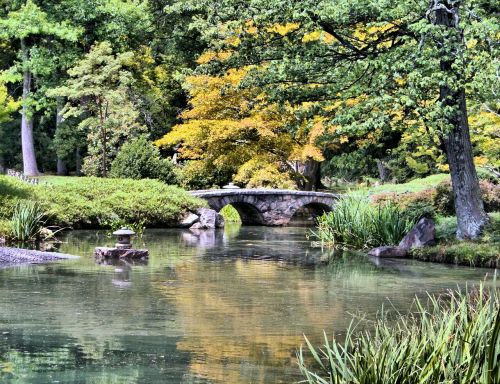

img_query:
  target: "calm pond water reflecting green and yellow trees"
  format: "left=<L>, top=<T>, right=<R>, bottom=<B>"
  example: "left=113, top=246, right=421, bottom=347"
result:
left=0, top=226, right=491, bottom=384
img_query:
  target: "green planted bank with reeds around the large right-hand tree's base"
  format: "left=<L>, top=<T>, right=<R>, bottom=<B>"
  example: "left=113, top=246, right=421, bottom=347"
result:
left=315, top=174, right=500, bottom=267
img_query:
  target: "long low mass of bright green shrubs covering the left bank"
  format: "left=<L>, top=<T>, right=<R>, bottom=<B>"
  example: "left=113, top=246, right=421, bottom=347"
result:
left=0, top=176, right=205, bottom=236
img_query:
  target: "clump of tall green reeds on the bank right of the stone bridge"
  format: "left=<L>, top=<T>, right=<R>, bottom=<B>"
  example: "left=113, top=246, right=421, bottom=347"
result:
left=313, top=196, right=417, bottom=249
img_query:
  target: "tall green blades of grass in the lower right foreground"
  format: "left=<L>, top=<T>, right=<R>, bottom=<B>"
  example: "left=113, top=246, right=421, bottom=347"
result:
left=298, top=285, right=500, bottom=384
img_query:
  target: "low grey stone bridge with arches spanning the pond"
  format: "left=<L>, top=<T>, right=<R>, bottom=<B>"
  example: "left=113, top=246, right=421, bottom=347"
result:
left=191, top=189, right=338, bottom=226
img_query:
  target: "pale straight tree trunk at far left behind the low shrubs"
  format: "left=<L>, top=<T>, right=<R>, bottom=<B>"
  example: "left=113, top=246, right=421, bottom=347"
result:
left=21, top=70, right=40, bottom=176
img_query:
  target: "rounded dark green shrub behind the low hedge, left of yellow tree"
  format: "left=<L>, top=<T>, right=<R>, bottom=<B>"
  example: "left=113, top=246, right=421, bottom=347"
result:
left=110, top=136, right=177, bottom=184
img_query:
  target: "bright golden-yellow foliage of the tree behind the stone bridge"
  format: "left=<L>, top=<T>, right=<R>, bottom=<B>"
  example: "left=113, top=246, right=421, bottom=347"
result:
left=155, top=67, right=324, bottom=188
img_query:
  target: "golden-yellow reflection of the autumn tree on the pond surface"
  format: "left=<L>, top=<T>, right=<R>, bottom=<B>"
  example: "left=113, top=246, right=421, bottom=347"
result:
left=152, top=255, right=406, bottom=383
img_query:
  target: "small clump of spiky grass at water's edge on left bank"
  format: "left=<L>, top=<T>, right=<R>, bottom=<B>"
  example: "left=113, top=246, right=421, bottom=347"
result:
left=10, top=201, right=44, bottom=242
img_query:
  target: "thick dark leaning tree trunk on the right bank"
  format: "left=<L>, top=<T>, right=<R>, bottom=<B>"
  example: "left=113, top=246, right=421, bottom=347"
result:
left=431, top=0, right=488, bottom=239
